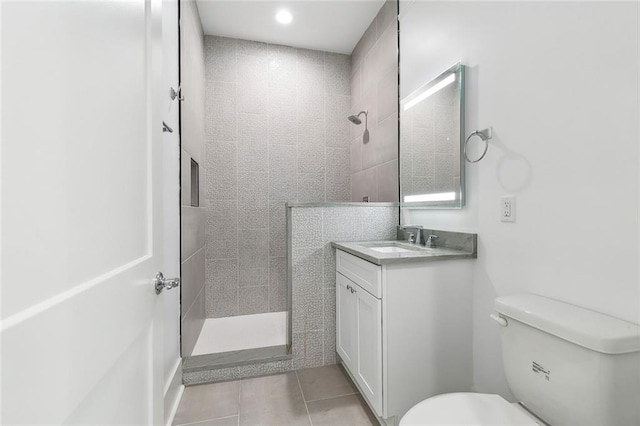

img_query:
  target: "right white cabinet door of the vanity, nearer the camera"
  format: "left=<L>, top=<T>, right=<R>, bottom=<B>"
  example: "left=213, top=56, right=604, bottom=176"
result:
left=354, top=286, right=382, bottom=416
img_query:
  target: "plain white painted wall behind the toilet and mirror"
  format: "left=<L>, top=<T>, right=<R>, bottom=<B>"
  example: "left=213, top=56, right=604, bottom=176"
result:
left=400, top=2, right=640, bottom=397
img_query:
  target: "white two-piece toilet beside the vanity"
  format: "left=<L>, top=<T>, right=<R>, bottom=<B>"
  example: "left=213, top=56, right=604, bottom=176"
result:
left=400, top=295, right=640, bottom=426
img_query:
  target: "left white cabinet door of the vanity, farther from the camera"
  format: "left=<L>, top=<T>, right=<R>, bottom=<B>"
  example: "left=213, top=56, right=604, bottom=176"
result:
left=336, top=273, right=357, bottom=374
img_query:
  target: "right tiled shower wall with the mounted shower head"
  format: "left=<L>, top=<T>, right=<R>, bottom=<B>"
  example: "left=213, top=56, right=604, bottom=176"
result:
left=350, top=0, right=398, bottom=202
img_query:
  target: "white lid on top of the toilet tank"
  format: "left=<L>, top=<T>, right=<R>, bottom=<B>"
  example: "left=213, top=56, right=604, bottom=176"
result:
left=495, top=294, right=640, bottom=354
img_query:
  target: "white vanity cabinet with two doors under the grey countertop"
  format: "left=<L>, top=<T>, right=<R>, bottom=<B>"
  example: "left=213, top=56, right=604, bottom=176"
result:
left=336, top=249, right=472, bottom=425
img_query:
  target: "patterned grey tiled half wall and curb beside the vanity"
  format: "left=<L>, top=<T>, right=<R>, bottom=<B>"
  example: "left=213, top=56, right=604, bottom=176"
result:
left=184, top=204, right=399, bottom=384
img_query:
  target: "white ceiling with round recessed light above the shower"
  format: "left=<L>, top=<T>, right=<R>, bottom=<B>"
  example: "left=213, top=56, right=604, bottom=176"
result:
left=196, top=0, right=384, bottom=55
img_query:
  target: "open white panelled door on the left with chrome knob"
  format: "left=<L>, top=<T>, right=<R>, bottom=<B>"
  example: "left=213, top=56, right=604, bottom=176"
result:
left=0, top=0, right=170, bottom=424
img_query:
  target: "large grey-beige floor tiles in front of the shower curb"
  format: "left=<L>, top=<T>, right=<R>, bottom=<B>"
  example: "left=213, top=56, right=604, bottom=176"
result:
left=173, top=365, right=378, bottom=426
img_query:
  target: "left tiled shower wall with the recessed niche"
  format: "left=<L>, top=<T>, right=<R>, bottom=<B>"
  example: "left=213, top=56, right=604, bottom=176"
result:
left=180, top=1, right=207, bottom=357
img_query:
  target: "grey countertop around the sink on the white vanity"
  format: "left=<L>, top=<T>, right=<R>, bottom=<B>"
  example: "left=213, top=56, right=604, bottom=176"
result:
left=331, top=241, right=477, bottom=265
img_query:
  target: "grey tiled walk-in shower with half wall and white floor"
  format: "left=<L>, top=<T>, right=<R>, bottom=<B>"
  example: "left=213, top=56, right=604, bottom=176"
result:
left=182, top=1, right=398, bottom=376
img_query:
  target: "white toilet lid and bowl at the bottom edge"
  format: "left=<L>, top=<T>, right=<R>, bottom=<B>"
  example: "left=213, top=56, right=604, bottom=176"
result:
left=400, top=392, right=544, bottom=426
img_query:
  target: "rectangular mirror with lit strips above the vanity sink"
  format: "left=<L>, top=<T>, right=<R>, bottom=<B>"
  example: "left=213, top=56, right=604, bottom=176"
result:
left=400, top=63, right=464, bottom=209
